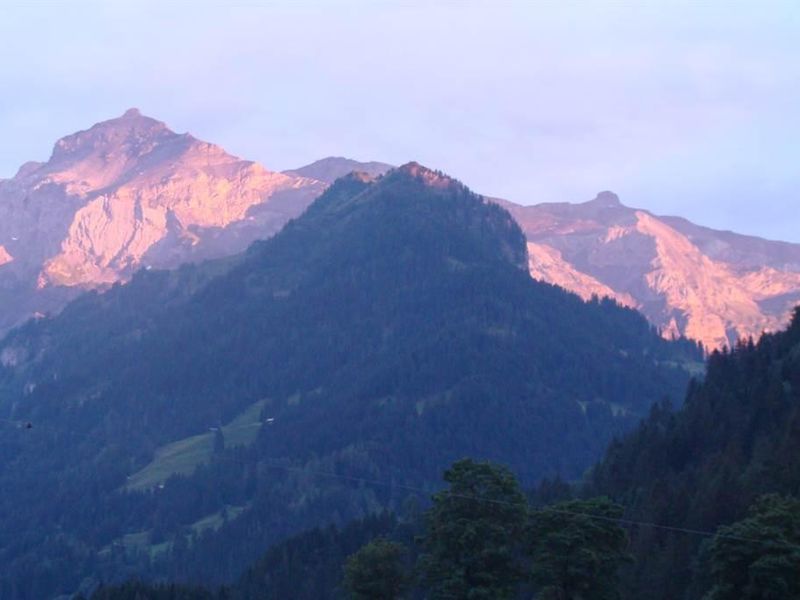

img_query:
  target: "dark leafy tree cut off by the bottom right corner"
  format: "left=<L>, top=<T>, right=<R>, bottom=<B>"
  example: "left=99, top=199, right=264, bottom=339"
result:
left=705, top=495, right=800, bottom=600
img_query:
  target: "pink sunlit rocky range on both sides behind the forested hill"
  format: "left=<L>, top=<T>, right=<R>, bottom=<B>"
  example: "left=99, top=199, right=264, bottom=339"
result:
left=0, top=109, right=800, bottom=349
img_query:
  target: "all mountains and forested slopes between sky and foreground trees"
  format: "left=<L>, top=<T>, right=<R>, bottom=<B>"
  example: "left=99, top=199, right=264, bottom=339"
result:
left=0, top=109, right=800, bottom=600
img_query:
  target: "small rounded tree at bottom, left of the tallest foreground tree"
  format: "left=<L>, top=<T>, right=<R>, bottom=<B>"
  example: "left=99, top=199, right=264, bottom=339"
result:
left=344, top=538, right=411, bottom=600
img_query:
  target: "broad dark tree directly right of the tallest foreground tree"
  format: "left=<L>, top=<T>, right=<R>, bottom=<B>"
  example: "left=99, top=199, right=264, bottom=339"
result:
left=528, top=498, right=630, bottom=600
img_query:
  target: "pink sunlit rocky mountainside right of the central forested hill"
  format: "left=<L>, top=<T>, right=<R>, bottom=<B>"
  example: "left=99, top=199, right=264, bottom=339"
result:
left=498, top=192, right=800, bottom=349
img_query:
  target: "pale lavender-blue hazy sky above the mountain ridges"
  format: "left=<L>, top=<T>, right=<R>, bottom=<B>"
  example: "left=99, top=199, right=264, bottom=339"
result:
left=0, top=0, right=800, bottom=242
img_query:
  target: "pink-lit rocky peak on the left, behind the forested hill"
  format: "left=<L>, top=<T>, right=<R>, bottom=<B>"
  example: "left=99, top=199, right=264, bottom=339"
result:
left=0, top=109, right=326, bottom=330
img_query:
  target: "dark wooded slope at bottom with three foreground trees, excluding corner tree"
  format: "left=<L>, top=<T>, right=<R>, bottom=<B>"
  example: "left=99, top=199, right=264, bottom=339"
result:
left=87, top=459, right=628, bottom=600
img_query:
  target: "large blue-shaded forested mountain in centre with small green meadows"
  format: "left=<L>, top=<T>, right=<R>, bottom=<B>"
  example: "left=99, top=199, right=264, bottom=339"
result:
left=0, top=163, right=697, bottom=600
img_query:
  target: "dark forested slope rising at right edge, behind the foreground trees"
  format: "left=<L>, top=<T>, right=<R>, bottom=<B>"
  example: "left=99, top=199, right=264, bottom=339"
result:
left=587, top=308, right=800, bottom=600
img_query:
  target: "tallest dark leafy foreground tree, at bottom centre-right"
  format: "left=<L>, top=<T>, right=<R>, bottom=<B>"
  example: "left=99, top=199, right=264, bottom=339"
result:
left=420, top=459, right=527, bottom=600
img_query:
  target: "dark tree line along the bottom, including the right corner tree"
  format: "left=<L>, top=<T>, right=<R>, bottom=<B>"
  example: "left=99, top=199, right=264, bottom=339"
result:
left=91, top=459, right=800, bottom=600
